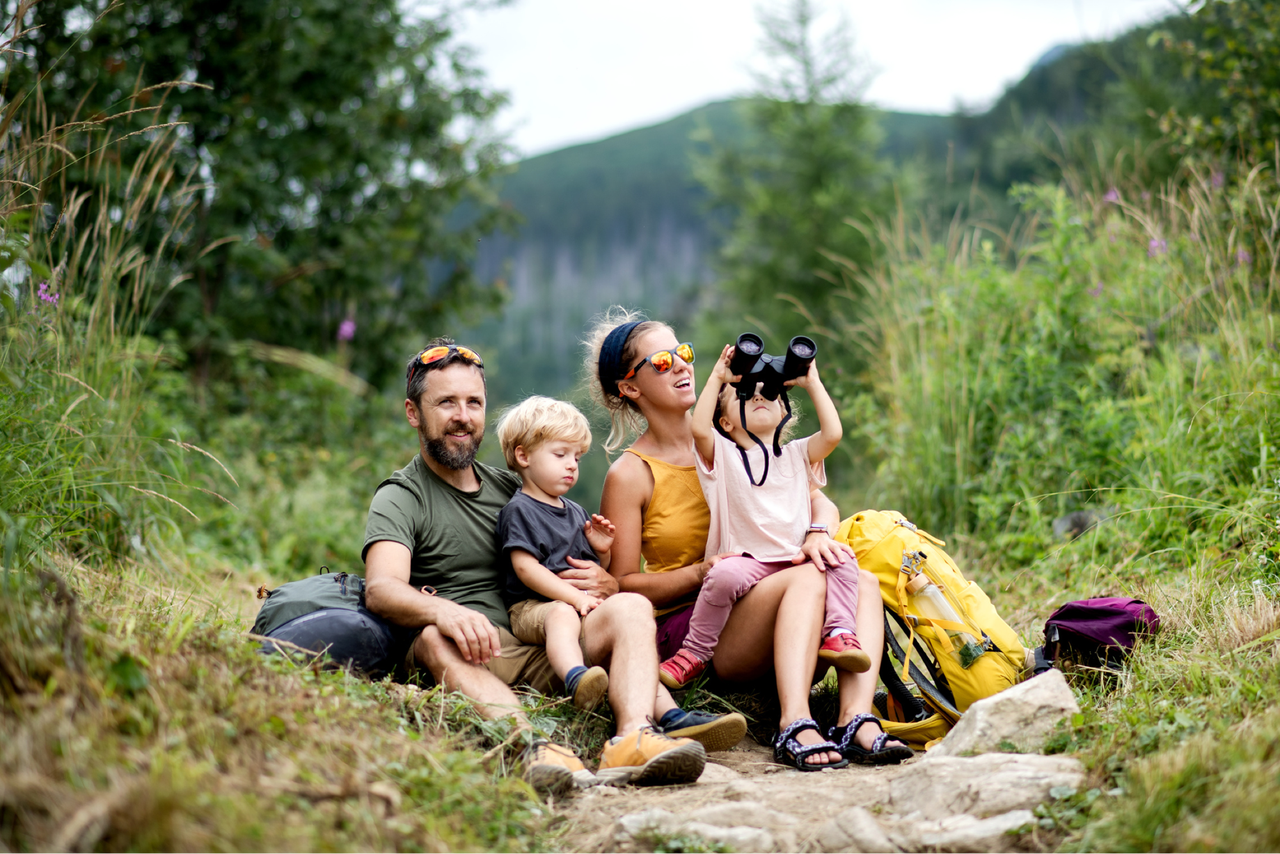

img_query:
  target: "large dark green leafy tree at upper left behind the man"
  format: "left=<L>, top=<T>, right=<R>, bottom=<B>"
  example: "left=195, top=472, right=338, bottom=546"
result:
left=4, top=0, right=511, bottom=379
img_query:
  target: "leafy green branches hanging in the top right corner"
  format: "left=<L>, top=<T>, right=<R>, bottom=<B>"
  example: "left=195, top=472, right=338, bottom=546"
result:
left=1152, top=0, right=1280, bottom=174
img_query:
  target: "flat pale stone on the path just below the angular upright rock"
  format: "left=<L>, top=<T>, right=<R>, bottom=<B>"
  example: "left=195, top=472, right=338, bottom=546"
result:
left=886, top=752, right=1084, bottom=819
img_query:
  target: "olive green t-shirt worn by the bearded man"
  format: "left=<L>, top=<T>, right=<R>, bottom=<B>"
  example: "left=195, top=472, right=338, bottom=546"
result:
left=361, top=455, right=520, bottom=629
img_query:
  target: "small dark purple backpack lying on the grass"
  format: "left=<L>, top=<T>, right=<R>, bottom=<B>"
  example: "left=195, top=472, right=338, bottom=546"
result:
left=1044, top=597, right=1160, bottom=670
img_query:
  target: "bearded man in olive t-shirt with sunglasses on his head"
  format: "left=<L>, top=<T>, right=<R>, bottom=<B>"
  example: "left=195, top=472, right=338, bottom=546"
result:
left=364, top=338, right=746, bottom=791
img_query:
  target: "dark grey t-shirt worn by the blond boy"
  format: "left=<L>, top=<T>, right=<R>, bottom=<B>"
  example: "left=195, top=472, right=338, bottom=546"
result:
left=497, top=492, right=598, bottom=607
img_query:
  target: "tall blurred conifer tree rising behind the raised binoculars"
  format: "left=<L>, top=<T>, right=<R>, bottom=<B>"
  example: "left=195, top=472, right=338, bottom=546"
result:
left=695, top=0, right=891, bottom=352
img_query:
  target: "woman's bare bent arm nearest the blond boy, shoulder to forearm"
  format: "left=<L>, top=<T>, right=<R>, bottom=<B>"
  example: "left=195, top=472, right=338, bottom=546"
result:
left=600, top=453, right=716, bottom=607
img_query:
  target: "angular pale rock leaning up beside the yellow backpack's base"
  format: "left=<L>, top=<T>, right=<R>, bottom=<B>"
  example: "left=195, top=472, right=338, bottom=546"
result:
left=924, top=670, right=1080, bottom=762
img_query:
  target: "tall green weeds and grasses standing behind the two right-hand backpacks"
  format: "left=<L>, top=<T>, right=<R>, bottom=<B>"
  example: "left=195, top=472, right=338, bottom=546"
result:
left=845, top=167, right=1280, bottom=578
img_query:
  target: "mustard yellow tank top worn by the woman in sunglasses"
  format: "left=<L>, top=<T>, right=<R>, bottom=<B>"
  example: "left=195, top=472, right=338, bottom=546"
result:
left=627, top=448, right=712, bottom=615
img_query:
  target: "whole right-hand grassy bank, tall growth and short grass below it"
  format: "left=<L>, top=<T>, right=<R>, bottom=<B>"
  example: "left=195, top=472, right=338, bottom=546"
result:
left=832, top=158, right=1280, bottom=851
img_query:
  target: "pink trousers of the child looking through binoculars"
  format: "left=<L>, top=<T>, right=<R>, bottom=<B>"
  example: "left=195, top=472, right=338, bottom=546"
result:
left=685, top=554, right=858, bottom=661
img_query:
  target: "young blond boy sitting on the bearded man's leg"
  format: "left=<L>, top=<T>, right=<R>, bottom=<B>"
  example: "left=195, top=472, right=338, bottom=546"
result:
left=497, top=397, right=614, bottom=709
